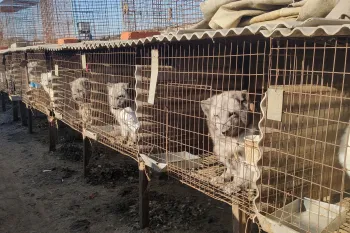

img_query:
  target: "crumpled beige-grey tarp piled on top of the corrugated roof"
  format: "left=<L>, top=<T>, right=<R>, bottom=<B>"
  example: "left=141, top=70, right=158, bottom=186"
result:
left=193, top=0, right=350, bottom=29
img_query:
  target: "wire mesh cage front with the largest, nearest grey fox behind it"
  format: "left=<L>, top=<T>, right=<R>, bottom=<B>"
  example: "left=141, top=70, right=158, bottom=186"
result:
left=136, top=37, right=268, bottom=211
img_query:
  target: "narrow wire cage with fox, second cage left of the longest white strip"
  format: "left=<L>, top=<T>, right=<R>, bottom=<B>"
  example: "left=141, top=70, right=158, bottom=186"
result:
left=51, top=51, right=90, bottom=132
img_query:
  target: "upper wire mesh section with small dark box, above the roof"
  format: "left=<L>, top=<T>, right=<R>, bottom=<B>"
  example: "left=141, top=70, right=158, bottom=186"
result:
left=40, top=0, right=122, bottom=43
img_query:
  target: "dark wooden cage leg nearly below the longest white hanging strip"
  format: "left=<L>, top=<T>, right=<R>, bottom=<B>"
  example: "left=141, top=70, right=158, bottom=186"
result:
left=139, top=162, right=149, bottom=229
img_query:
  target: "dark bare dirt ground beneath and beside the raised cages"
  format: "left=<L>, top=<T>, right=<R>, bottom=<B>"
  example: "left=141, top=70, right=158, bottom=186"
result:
left=0, top=102, right=232, bottom=233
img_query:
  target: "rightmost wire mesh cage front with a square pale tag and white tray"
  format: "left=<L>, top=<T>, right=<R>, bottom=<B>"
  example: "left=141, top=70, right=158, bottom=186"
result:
left=257, top=39, right=350, bottom=232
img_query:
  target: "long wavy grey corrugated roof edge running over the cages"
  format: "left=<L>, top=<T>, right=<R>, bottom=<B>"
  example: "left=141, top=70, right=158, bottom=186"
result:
left=0, top=19, right=350, bottom=53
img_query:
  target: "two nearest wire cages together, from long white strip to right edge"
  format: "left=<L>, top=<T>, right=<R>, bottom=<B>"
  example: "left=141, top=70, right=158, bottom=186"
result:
left=135, top=37, right=350, bottom=232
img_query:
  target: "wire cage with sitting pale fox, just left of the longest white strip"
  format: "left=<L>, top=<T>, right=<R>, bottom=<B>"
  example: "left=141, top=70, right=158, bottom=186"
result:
left=85, top=48, right=138, bottom=159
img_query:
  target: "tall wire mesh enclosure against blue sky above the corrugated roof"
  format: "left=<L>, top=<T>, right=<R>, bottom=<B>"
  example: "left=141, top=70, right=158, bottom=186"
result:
left=0, top=0, right=206, bottom=46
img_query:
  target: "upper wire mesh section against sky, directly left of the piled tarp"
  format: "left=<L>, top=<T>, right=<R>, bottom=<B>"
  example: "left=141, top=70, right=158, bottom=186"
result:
left=122, top=0, right=203, bottom=31
